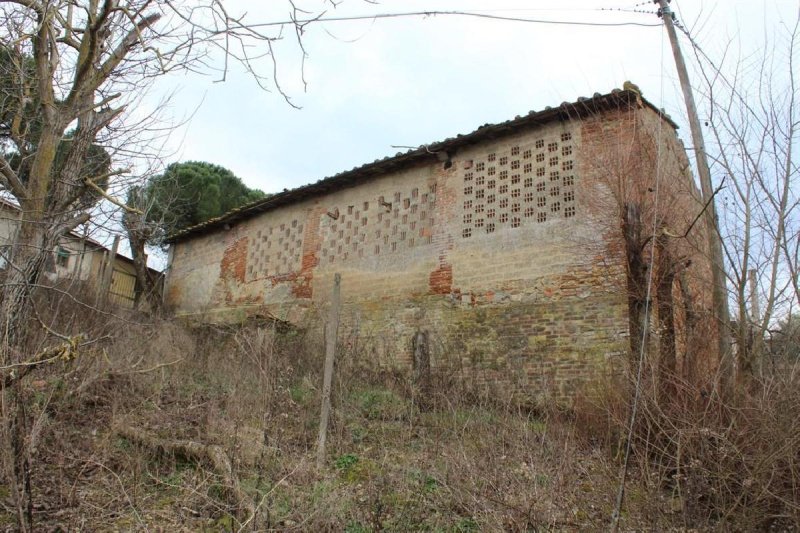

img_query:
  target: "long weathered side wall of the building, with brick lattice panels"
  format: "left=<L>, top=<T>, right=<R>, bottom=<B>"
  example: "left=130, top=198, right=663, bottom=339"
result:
left=166, top=106, right=708, bottom=398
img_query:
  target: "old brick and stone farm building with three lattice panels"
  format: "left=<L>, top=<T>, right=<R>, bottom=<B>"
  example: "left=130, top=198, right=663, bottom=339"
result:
left=165, top=90, right=709, bottom=398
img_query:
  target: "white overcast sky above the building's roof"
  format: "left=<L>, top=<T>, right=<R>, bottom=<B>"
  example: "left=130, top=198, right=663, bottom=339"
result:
left=142, top=0, right=798, bottom=192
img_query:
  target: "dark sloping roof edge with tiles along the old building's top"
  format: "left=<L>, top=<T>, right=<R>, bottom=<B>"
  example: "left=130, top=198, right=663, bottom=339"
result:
left=167, top=89, right=678, bottom=243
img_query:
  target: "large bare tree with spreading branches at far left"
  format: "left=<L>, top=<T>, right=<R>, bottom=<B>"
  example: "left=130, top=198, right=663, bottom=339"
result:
left=0, top=0, right=332, bottom=531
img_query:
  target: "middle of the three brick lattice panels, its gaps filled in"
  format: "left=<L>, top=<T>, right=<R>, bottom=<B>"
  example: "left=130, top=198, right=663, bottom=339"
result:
left=317, top=185, right=436, bottom=265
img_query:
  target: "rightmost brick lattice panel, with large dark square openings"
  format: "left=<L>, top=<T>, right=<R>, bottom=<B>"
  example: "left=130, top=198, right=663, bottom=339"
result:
left=461, top=132, right=575, bottom=239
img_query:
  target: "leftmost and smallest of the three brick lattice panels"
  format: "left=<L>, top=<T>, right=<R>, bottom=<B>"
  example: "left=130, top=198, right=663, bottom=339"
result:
left=247, top=220, right=303, bottom=280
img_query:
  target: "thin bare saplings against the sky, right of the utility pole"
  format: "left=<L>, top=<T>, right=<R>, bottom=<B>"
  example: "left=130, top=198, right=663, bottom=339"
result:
left=695, top=6, right=800, bottom=381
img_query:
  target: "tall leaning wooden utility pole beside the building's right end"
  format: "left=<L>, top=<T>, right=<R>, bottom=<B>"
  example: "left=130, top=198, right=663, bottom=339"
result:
left=653, top=0, right=733, bottom=389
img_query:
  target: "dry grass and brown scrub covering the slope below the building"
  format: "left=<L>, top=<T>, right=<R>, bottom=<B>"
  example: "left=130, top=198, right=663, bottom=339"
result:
left=0, top=294, right=800, bottom=532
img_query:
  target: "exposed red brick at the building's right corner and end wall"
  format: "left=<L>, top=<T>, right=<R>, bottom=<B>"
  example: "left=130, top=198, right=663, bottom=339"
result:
left=581, top=100, right=718, bottom=379
